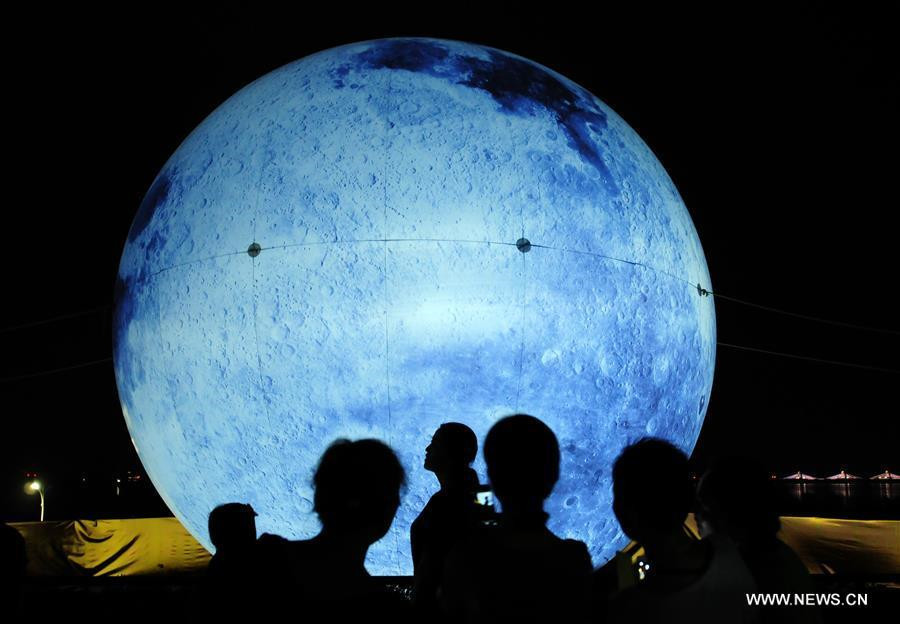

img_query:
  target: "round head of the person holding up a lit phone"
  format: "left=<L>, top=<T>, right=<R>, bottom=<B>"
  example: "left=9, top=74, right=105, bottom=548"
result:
left=484, top=414, right=559, bottom=515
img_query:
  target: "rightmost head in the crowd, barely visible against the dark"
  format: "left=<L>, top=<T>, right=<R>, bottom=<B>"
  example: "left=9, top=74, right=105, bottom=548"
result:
left=696, top=457, right=781, bottom=544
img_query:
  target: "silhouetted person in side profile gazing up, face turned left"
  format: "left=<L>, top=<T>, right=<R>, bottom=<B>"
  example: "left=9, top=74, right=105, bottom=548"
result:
left=410, top=423, right=478, bottom=616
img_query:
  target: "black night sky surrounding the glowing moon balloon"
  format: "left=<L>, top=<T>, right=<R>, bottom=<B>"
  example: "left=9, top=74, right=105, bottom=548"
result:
left=0, top=5, right=900, bottom=516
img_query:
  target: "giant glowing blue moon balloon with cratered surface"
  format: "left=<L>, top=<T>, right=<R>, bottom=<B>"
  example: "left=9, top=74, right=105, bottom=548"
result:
left=114, top=39, right=716, bottom=574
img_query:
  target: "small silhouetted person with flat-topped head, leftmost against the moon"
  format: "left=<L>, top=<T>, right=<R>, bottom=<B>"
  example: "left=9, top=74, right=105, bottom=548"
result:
left=207, top=503, right=256, bottom=579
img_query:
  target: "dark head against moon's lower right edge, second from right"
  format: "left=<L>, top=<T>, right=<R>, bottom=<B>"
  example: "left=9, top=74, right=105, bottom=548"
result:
left=612, top=438, right=693, bottom=545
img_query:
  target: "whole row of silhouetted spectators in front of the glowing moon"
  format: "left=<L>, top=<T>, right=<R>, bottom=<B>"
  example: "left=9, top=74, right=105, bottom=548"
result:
left=200, top=414, right=820, bottom=624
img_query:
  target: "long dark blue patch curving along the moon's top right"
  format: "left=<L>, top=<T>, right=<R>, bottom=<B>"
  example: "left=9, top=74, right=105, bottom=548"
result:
left=342, top=39, right=618, bottom=194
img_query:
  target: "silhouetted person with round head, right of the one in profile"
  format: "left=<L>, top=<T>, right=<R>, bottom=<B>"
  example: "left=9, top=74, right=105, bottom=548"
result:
left=440, top=414, right=591, bottom=622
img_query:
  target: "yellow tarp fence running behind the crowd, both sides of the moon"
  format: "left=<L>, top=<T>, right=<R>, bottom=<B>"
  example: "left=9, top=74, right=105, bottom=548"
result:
left=12, top=517, right=900, bottom=576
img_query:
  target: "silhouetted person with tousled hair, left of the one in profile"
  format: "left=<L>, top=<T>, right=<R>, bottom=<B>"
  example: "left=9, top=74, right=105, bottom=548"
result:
left=270, top=439, right=408, bottom=622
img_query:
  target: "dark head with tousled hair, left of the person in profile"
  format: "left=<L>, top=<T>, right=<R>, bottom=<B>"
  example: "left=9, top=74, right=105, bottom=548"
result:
left=313, top=440, right=406, bottom=544
